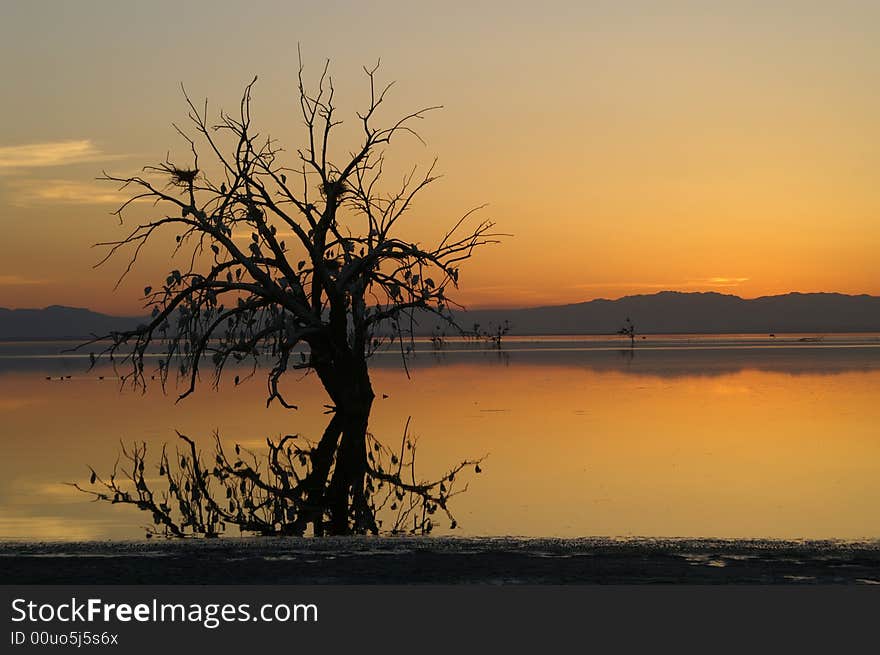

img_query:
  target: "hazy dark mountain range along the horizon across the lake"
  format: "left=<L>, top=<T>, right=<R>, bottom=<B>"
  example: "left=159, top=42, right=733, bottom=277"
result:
left=0, top=291, right=880, bottom=340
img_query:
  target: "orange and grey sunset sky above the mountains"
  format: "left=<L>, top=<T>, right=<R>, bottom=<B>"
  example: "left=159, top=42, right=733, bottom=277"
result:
left=0, top=0, right=880, bottom=313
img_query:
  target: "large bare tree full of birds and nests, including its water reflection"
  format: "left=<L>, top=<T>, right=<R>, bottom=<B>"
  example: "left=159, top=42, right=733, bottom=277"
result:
left=79, top=55, right=500, bottom=535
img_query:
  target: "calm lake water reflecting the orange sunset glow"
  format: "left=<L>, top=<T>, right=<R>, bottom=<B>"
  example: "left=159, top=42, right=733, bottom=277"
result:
left=0, top=335, right=880, bottom=540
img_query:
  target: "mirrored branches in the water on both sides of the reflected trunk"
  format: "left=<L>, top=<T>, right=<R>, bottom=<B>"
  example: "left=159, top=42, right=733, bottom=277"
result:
left=74, top=421, right=481, bottom=538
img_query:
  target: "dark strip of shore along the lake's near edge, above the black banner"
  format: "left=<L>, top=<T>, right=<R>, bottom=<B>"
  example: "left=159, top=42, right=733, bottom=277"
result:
left=0, top=538, right=880, bottom=584
